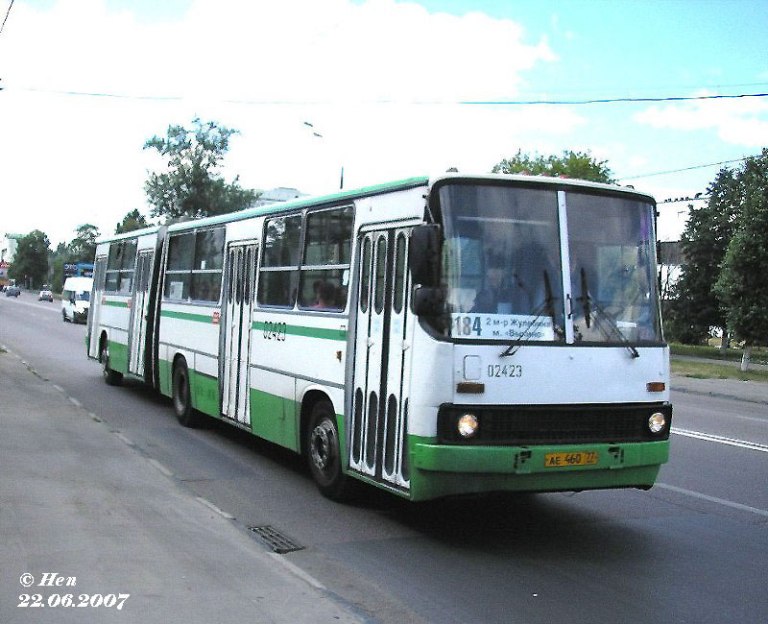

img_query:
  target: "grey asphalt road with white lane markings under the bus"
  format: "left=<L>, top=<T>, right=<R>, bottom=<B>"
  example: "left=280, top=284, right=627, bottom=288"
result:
left=0, top=294, right=768, bottom=624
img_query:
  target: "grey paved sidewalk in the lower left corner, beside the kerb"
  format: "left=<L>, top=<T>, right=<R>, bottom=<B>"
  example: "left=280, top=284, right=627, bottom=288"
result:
left=0, top=353, right=360, bottom=624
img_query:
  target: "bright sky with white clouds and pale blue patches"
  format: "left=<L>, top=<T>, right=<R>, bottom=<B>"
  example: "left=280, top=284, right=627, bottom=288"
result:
left=0, top=0, right=768, bottom=247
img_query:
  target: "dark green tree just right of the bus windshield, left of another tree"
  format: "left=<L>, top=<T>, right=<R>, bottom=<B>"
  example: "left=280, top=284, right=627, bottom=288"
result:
left=667, top=168, right=739, bottom=345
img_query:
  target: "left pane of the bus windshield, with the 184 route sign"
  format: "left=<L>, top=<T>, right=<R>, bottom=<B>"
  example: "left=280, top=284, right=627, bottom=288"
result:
left=440, top=185, right=563, bottom=341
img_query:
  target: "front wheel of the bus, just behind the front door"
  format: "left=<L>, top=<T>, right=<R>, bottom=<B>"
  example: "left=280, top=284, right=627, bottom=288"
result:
left=307, top=401, right=353, bottom=501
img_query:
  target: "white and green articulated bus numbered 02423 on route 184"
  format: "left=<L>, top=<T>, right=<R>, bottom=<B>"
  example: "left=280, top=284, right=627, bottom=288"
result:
left=87, top=174, right=672, bottom=501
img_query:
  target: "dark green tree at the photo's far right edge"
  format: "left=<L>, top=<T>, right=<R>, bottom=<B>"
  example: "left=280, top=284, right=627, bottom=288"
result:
left=714, top=149, right=768, bottom=370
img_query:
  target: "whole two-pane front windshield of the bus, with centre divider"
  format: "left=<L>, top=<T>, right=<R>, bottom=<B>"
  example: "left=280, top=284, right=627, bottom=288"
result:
left=439, top=182, right=661, bottom=343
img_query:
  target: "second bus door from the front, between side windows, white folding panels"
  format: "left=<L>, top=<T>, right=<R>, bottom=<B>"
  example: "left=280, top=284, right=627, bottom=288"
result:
left=219, top=243, right=258, bottom=425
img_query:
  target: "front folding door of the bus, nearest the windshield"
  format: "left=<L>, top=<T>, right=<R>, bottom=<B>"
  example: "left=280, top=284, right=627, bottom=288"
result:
left=349, top=229, right=411, bottom=489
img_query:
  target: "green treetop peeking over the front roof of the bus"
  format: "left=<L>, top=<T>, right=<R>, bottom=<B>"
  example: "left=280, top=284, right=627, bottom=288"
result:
left=491, top=150, right=615, bottom=184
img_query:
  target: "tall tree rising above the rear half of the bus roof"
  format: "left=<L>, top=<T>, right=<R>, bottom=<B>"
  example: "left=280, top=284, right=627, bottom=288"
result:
left=144, top=118, right=258, bottom=220
